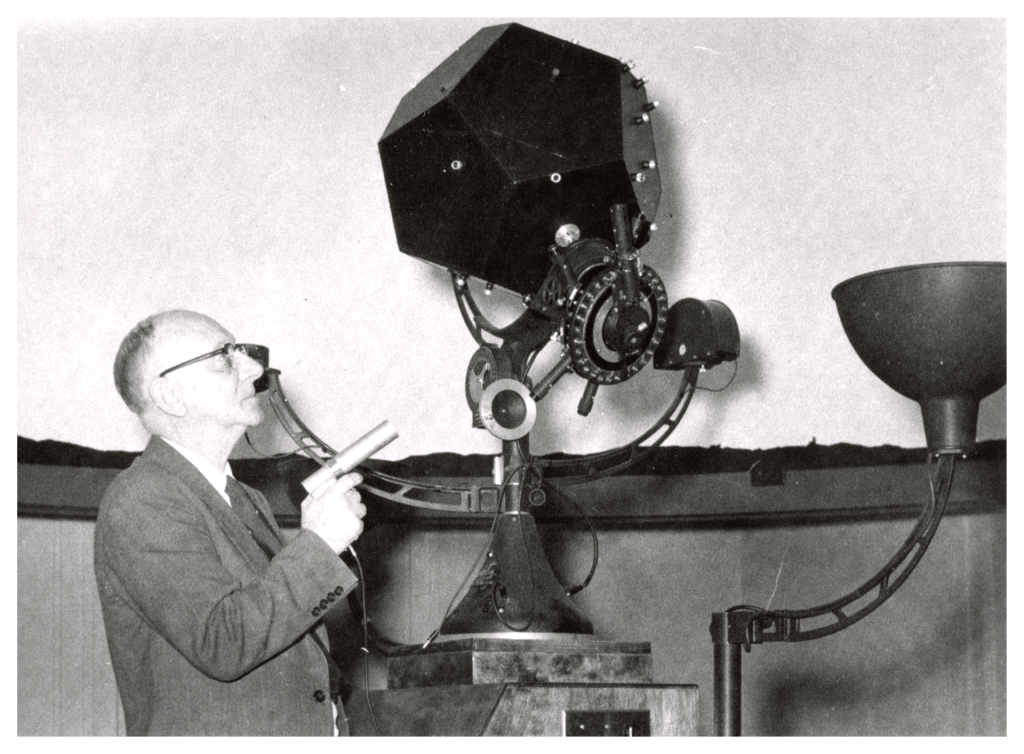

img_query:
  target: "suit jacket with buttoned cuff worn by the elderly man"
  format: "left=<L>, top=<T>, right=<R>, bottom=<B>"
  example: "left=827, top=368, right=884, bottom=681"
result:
left=95, top=437, right=356, bottom=736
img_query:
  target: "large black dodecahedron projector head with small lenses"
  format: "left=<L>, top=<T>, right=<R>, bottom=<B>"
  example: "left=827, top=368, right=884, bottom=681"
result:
left=379, top=24, right=662, bottom=294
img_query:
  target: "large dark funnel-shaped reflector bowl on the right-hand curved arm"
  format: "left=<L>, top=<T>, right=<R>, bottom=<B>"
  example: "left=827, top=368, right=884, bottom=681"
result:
left=833, top=262, right=1007, bottom=453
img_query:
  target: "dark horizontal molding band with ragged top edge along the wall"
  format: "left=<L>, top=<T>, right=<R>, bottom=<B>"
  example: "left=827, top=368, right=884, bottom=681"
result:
left=17, top=437, right=1007, bottom=529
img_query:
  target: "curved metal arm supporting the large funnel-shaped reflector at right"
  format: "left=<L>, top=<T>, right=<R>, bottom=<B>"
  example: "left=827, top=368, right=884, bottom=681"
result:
left=726, top=455, right=955, bottom=645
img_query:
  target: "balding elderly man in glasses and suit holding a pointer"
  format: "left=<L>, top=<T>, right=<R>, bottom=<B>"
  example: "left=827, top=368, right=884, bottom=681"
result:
left=95, top=311, right=366, bottom=736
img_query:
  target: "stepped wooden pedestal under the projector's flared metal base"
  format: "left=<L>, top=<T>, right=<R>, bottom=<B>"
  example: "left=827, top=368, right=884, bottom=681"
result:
left=345, top=636, right=697, bottom=736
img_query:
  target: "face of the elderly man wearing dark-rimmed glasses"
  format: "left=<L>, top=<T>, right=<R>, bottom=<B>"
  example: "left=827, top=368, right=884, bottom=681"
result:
left=152, top=315, right=263, bottom=434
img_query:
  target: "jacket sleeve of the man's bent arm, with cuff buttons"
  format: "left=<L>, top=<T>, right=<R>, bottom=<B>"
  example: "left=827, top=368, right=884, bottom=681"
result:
left=96, top=474, right=356, bottom=681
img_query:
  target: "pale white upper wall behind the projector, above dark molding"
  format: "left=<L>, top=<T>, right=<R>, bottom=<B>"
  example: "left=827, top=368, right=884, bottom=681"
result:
left=17, top=18, right=1007, bottom=458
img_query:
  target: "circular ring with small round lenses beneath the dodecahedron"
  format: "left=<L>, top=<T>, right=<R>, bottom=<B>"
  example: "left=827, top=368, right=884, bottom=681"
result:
left=566, top=267, right=669, bottom=385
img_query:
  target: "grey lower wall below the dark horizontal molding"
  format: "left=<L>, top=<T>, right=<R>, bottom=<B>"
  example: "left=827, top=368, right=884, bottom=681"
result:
left=18, top=513, right=1007, bottom=736
